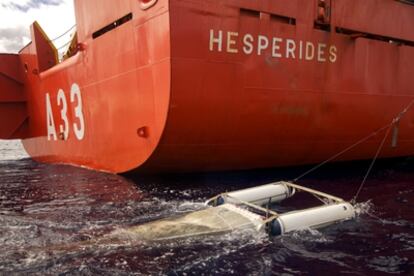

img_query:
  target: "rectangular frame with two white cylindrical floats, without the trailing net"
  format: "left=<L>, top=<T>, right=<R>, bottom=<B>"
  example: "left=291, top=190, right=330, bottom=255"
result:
left=206, top=182, right=355, bottom=236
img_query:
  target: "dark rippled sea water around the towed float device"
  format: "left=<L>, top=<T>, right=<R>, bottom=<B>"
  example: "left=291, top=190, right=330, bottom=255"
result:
left=0, top=141, right=414, bottom=275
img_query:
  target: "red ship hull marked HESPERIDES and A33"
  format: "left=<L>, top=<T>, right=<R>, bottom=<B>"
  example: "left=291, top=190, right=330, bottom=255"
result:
left=0, top=0, right=414, bottom=173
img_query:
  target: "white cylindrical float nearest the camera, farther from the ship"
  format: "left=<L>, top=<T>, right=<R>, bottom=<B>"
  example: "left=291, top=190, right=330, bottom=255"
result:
left=269, top=202, right=355, bottom=236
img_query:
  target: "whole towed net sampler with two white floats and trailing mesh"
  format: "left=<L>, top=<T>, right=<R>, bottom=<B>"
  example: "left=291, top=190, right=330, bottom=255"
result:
left=111, top=182, right=355, bottom=240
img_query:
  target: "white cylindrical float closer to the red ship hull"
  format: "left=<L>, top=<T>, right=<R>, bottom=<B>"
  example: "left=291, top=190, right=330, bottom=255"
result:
left=221, top=182, right=295, bottom=205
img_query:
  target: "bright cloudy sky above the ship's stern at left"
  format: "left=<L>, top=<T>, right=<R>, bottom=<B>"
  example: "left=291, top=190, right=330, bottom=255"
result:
left=0, top=0, right=75, bottom=53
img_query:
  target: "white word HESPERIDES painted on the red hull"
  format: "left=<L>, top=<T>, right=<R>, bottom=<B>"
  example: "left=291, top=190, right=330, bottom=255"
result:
left=209, top=29, right=338, bottom=63
